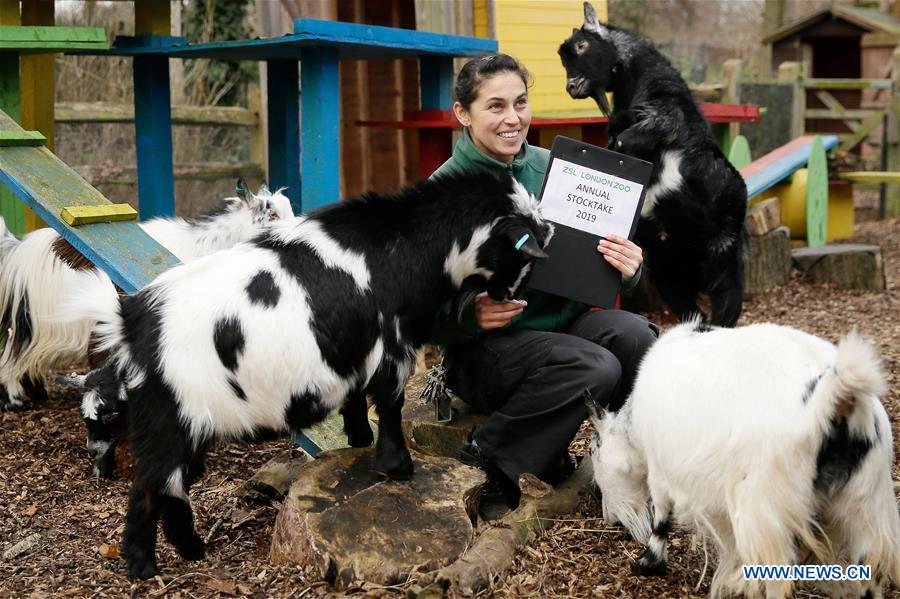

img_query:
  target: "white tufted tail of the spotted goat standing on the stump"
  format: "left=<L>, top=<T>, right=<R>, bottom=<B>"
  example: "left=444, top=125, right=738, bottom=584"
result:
left=57, top=270, right=124, bottom=351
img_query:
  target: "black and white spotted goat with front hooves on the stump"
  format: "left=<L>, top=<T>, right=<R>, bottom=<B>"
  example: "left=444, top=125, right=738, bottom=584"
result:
left=63, top=173, right=552, bottom=578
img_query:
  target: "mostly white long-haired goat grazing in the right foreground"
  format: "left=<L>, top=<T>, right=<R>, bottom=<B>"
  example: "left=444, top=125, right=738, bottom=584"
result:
left=589, top=322, right=900, bottom=598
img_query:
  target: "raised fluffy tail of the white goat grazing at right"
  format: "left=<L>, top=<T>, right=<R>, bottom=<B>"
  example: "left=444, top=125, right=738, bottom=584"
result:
left=809, top=329, right=887, bottom=434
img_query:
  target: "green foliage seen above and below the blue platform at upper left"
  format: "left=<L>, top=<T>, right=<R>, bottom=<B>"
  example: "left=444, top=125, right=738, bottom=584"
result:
left=182, top=0, right=258, bottom=106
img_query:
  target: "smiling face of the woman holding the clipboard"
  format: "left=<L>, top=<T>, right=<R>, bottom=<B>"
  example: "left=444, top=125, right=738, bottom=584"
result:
left=453, top=71, right=531, bottom=164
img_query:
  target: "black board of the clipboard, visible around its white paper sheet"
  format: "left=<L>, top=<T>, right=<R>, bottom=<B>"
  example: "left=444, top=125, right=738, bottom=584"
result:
left=528, top=135, right=653, bottom=308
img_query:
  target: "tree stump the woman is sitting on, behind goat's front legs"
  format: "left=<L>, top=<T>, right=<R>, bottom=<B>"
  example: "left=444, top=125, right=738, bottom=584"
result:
left=403, top=373, right=487, bottom=458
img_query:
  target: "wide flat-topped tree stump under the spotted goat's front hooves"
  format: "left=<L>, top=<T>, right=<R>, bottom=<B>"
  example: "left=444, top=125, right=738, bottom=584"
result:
left=271, top=448, right=484, bottom=587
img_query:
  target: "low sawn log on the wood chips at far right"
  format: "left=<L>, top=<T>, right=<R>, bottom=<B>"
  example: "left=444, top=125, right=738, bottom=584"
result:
left=791, top=244, right=886, bottom=291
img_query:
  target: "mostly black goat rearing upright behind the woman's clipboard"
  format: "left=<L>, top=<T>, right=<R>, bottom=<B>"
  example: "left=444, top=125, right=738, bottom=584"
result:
left=559, top=2, right=747, bottom=326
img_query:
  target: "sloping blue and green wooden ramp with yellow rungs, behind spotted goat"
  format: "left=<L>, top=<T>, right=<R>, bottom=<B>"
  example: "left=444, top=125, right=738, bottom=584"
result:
left=0, top=111, right=347, bottom=457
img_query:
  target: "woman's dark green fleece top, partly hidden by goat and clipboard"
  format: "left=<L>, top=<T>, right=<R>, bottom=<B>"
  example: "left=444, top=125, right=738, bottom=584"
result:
left=431, top=129, right=641, bottom=349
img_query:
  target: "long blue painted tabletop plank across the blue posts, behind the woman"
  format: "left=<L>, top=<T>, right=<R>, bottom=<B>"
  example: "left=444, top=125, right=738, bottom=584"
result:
left=77, top=19, right=498, bottom=61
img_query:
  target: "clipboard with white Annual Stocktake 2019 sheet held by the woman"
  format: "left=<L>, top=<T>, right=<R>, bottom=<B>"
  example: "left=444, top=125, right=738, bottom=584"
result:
left=528, top=136, right=653, bottom=308
